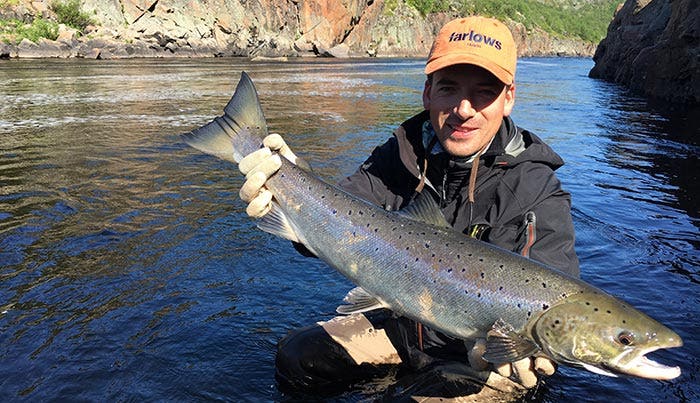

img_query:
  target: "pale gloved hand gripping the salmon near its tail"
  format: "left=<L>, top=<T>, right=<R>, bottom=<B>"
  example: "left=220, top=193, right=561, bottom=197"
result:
left=238, top=133, right=310, bottom=218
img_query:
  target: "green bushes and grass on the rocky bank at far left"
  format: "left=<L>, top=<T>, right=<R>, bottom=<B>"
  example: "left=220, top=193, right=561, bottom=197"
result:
left=0, top=0, right=95, bottom=44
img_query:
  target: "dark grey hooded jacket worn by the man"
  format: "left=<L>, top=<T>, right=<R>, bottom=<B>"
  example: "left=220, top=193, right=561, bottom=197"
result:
left=340, top=111, right=579, bottom=277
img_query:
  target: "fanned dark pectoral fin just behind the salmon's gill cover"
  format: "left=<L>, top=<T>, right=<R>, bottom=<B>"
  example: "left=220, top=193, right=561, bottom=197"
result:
left=483, top=319, right=539, bottom=363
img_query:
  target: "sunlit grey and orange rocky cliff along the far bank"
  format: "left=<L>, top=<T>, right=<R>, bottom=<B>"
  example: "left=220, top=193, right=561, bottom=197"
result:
left=0, top=0, right=595, bottom=58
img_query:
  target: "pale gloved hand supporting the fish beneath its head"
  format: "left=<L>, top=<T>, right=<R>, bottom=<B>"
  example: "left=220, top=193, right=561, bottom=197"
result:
left=468, top=339, right=556, bottom=389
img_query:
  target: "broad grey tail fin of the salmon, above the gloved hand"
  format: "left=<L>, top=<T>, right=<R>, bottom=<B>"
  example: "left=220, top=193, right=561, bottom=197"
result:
left=182, top=72, right=268, bottom=163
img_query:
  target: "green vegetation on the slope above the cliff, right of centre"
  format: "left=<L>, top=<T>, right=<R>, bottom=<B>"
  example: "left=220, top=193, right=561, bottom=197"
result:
left=406, top=0, right=621, bottom=43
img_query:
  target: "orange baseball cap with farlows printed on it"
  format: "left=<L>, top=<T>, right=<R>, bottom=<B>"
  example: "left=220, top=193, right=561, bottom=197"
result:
left=425, top=16, right=518, bottom=84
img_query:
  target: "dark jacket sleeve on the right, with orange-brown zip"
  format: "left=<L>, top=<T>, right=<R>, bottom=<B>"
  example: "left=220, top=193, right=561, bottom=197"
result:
left=489, top=164, right=580, bottom=277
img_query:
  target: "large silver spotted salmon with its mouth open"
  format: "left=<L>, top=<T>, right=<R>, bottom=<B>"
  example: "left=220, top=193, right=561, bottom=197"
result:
left=183, top=73, right=682, bottom=379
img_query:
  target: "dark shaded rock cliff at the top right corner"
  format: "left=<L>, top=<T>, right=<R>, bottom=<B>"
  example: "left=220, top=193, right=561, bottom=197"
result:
left=589, top=0, right=700, bottom=106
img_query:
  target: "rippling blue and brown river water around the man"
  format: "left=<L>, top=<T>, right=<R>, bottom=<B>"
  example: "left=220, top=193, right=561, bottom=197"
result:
left=0, top=59, right=700, bottom=402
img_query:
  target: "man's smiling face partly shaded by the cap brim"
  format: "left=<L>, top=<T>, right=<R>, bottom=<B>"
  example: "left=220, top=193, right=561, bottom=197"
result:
left=423, top=64, right=515, bottom=157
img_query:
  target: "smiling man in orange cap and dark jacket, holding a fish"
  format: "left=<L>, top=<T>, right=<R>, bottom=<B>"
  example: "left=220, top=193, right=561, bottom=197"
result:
left=239, top=17, right=579, bottom=399
